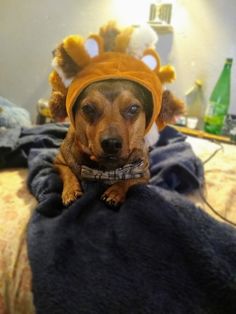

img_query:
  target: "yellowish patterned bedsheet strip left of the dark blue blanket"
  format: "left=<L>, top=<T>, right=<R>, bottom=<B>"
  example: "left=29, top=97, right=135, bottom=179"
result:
left=0, top=168, right=36, bottom=314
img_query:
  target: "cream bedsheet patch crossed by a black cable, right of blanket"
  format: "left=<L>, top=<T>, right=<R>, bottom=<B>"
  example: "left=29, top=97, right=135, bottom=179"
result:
left=187, top=137, right=236, bottom=224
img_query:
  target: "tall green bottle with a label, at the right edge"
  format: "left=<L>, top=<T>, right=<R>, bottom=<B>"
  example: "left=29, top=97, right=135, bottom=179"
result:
left=204, top=58, right=233, bottom=134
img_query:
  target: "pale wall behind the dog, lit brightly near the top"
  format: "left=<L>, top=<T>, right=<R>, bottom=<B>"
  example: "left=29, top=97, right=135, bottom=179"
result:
left=0, top=0, right=236, bottom=117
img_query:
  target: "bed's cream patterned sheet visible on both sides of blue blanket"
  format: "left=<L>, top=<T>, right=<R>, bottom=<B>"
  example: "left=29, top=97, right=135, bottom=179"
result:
left=0, top=131, right=236, bottom=314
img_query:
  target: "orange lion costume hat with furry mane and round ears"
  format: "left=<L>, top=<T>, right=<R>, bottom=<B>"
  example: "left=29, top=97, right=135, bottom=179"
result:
left=50, top=22, right=175, bottom=133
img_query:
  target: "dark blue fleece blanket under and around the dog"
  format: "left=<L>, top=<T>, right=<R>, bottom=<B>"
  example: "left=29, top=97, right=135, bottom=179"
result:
left=0, top=126, right=236, bottom=314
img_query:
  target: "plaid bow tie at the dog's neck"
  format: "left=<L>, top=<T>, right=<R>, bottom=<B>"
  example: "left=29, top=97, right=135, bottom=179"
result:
left=80, top=160, right=148, bottom=184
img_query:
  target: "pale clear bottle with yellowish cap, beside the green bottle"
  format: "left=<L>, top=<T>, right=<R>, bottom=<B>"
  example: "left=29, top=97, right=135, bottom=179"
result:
left=185, top=80, right=205, bottom=129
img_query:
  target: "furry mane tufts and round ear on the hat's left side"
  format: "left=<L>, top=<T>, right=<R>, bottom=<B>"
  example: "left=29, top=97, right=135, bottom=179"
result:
left=49, top=35, right=103, bottom=121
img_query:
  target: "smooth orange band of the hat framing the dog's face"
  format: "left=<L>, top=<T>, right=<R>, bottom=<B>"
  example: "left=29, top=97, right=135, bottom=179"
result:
left=66, top=52, right=162, bottom=131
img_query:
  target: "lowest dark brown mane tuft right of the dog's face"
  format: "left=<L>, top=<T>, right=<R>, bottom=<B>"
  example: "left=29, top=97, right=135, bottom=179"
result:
left=156, top=90, right=186, bottom=128
